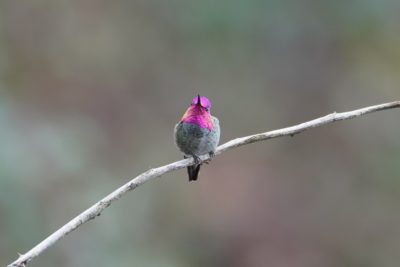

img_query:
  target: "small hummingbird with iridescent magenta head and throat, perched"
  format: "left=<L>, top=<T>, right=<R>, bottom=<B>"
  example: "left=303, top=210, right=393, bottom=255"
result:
left=175, top=95, right=220, bottom=181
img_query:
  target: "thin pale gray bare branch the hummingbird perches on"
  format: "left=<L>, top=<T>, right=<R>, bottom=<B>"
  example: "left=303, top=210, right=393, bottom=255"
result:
left=8, top=101, right=400, bottom=267
